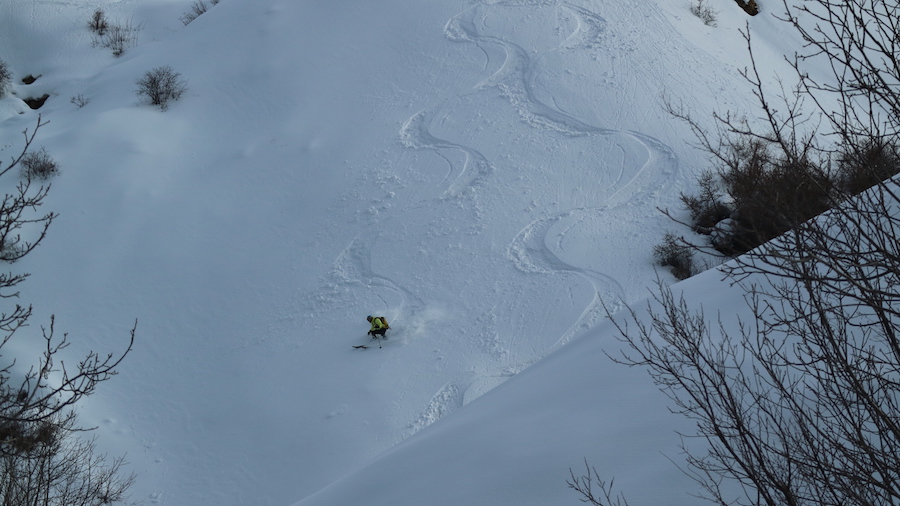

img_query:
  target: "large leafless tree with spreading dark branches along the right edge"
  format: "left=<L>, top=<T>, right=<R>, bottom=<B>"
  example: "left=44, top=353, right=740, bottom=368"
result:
left=569, top=0, right=900, bottom=506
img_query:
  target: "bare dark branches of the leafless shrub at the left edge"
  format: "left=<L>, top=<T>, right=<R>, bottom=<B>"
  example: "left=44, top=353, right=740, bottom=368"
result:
left=0, top=117, right=137, bottom=506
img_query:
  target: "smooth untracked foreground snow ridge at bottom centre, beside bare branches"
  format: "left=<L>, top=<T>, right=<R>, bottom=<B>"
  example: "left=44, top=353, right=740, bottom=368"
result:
left=297, top=318, right=694, bottom=506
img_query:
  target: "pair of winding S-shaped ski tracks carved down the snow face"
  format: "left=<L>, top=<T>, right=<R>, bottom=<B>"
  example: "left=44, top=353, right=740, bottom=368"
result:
left=307, top=0, right=677, bottom=436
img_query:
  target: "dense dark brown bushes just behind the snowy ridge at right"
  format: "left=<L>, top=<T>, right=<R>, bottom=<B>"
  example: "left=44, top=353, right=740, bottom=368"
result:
left=654, top=127, right=900, bottom=279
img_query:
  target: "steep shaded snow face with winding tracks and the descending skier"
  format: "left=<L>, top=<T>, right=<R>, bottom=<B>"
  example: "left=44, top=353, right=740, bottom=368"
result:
left=0, top=0, right=788, bottom=506
